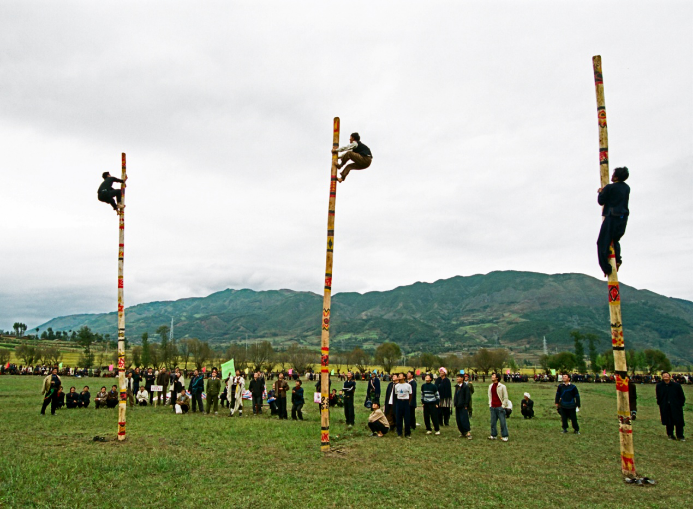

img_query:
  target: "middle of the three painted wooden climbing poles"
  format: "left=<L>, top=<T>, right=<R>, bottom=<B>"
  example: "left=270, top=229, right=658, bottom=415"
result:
left=320, top=117, right=339, bottom=452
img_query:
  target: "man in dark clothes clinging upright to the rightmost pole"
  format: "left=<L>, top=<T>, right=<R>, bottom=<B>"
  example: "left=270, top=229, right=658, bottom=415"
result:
left=597, top=166, right=630, bottom=276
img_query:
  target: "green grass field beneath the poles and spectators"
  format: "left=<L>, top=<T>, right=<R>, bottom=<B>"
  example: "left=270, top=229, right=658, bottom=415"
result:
left=0, top=376, right=693, bottom=508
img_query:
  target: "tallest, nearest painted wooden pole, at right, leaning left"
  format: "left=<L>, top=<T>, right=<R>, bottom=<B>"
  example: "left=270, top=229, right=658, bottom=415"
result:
left=592, top=55, right=636, bottom=478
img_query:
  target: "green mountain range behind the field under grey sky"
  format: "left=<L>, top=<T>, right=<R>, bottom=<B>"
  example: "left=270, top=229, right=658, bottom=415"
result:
left=39, top=271, right=693, bottom=364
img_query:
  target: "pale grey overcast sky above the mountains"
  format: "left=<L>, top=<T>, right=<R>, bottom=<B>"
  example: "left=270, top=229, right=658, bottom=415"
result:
left=0, top=0, right=693, bottom=329
